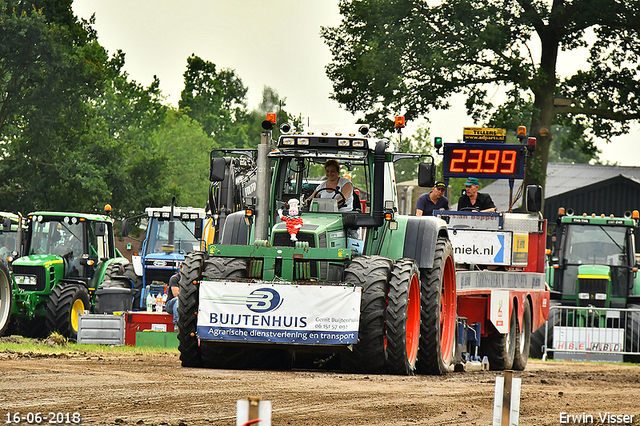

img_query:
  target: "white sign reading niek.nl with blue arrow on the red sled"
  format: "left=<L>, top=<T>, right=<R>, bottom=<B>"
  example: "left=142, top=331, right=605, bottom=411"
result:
left=449, top=229, right=512, bottom=266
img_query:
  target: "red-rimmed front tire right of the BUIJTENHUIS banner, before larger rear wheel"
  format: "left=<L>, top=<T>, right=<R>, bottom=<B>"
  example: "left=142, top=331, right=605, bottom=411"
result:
left=386, top=259, right=420, bottom=376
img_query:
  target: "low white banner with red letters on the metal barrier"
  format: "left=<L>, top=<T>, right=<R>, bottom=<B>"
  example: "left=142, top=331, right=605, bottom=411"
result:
left=553, top=326, right=624, bottom=352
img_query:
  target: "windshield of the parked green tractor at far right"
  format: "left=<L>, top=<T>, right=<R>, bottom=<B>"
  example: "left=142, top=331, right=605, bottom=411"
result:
left=563, top=225, right=628, bottom=266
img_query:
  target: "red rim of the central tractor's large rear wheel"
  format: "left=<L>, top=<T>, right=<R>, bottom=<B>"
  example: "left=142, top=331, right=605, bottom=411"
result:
left=440, top=256, right=456, bottom=361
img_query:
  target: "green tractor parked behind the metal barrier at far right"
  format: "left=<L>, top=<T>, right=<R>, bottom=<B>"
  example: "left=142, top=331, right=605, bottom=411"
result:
left=532, top=209, right=640, bottom=362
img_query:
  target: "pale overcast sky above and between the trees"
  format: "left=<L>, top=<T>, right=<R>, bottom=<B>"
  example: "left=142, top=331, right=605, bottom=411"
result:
left=73, top=0, right=640, bottom=166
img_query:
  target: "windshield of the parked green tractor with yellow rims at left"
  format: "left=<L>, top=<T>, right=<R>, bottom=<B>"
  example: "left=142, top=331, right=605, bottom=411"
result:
left=29, top=217, right=84, bottom=257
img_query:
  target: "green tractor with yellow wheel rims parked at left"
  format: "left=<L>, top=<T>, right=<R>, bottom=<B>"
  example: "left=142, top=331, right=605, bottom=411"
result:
left=11, top=206, right=128, bottom=339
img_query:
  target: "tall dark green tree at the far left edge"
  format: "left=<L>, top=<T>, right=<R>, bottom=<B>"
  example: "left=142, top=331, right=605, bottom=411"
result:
left=0, top=0, right=114, bottom=211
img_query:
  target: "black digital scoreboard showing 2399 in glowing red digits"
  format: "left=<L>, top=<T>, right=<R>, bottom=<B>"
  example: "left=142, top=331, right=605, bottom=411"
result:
left=443, top=143, right=526, bottom=179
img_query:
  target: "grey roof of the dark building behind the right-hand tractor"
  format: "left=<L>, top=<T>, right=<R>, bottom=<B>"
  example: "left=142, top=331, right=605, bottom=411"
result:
left=480, top=163, right=640, bottom=211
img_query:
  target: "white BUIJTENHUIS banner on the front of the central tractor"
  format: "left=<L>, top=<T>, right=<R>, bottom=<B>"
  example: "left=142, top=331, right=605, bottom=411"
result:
left=197, top=280, right=361, bottom=345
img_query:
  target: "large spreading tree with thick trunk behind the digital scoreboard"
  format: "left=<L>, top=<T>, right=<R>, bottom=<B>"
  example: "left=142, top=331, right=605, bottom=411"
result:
left=322, top=0, right=640, bottom=185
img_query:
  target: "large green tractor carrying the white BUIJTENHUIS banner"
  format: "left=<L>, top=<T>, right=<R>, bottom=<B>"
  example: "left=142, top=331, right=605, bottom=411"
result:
left=178, top=122, right=456, bottom=375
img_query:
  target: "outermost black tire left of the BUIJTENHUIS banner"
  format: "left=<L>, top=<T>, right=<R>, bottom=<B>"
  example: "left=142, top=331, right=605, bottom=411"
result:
left=178, top=252, right=205, bottom=367
